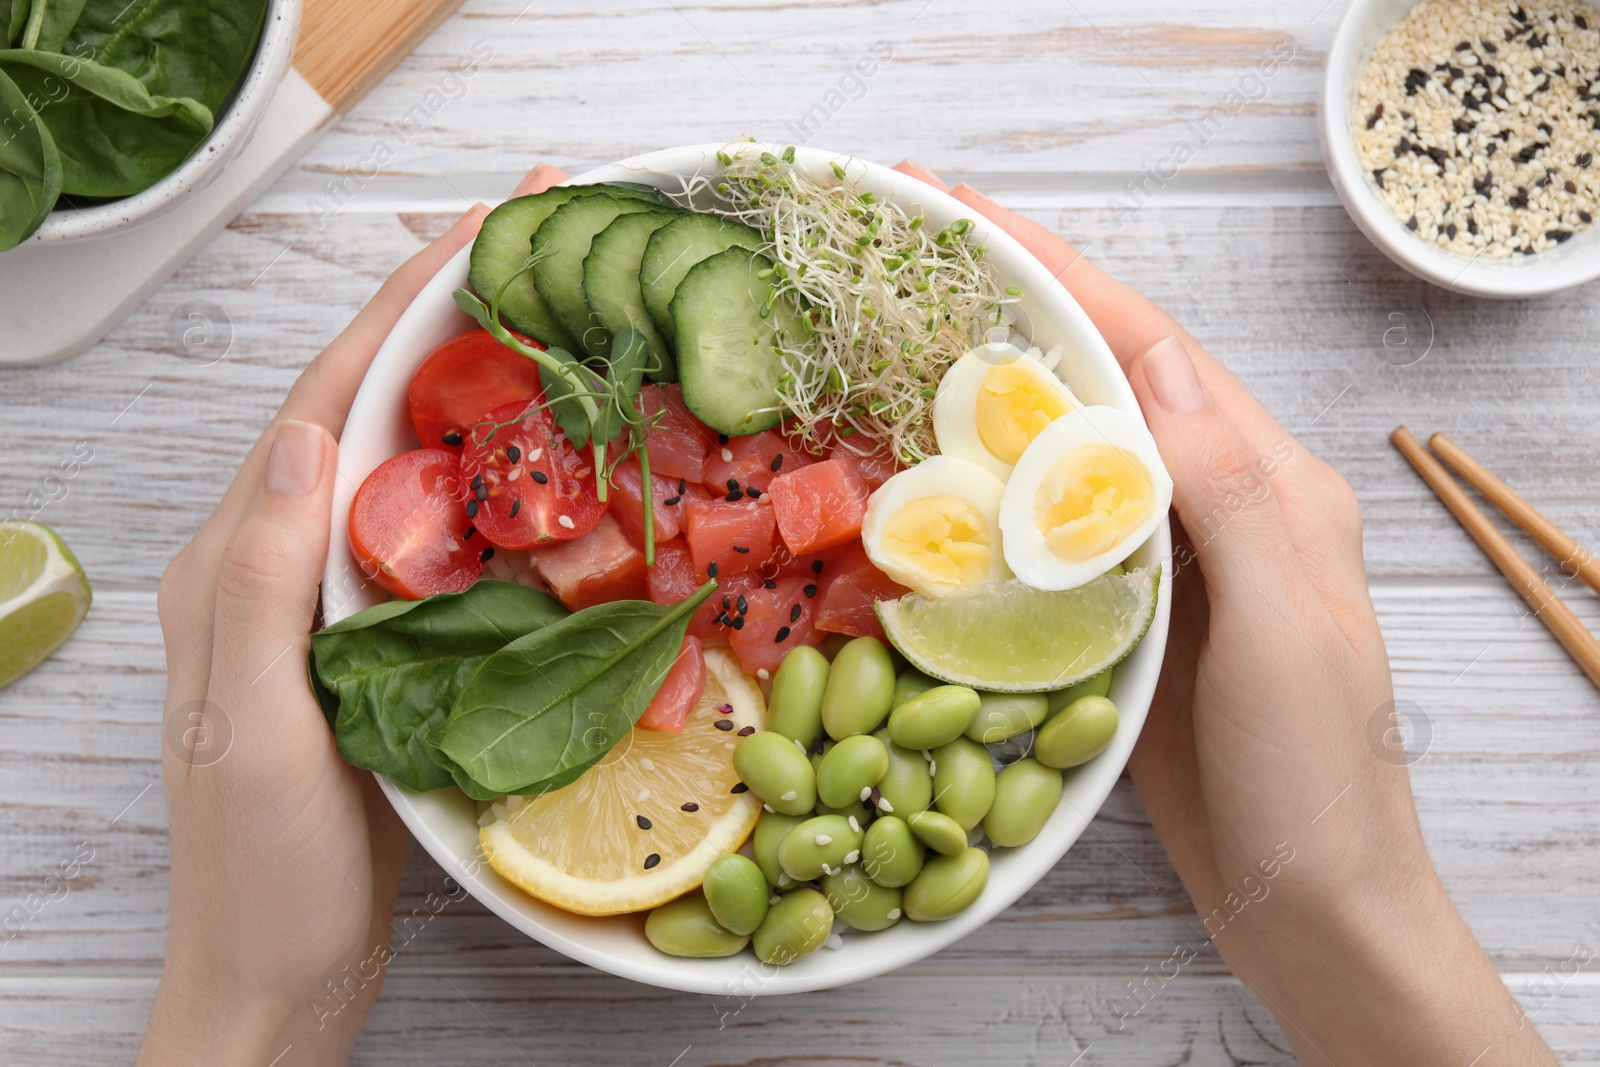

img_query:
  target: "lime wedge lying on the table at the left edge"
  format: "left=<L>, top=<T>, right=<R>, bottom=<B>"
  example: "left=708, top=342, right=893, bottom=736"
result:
left=0, top=520, right=90, bottom=688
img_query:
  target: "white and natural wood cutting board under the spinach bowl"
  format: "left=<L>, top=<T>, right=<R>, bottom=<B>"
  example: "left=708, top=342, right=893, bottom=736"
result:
left=0, top=0, right=461, bottom=363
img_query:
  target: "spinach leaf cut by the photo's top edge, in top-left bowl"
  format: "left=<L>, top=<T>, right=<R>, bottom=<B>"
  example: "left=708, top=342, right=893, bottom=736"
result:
left=66, top=0, right=267, bottom=112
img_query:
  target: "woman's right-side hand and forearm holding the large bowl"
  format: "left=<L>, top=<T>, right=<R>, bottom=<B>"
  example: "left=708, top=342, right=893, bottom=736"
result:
left=899, top=162, right=1555, bottom=1067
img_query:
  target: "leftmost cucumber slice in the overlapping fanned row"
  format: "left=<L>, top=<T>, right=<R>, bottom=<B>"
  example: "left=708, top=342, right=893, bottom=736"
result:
left=467, top=184, right=670, bottom=349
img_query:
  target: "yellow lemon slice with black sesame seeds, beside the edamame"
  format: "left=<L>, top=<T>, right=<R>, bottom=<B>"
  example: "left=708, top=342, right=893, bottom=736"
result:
left=478, top=648, right=765, bottom=915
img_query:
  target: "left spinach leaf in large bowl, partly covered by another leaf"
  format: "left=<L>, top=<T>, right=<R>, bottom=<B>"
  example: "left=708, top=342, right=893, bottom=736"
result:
left=310, top=579, right=566, bottom=795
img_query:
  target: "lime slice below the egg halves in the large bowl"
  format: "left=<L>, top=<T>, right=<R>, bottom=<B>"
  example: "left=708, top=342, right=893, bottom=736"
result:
left=878, top=566, right=1160, bottom=693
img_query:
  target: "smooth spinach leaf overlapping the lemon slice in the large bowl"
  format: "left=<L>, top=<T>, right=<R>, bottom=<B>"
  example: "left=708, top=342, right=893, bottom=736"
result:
left=440, top=581, right=717, bottom=793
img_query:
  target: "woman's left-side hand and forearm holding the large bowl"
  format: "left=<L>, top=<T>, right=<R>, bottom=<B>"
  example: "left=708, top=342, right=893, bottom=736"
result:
left=141, top=166, right=565, bottom=1067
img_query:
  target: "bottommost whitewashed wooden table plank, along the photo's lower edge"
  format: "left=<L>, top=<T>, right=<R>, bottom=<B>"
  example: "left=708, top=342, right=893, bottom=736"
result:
left=0, top=971, right=1600, bottom=1067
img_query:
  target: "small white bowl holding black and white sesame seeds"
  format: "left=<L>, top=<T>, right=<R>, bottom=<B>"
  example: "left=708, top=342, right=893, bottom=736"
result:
left=1320, top=0, right=1600, bottom=299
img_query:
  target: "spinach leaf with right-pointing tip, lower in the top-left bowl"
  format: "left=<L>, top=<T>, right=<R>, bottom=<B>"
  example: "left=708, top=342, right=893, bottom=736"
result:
left=0, top=48, right=211, bottom=197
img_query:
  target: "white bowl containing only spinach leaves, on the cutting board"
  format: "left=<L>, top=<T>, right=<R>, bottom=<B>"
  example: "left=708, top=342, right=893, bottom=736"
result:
left=29, top=0, right=301, bottom=243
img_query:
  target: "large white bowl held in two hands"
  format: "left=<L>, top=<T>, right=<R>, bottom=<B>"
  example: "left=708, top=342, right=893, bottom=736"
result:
left=323, top=144, right=1171, bottom=997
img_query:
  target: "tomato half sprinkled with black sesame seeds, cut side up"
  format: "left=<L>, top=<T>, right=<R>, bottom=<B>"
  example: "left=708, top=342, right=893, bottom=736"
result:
left=461, top=400, right=606, bottom=549
